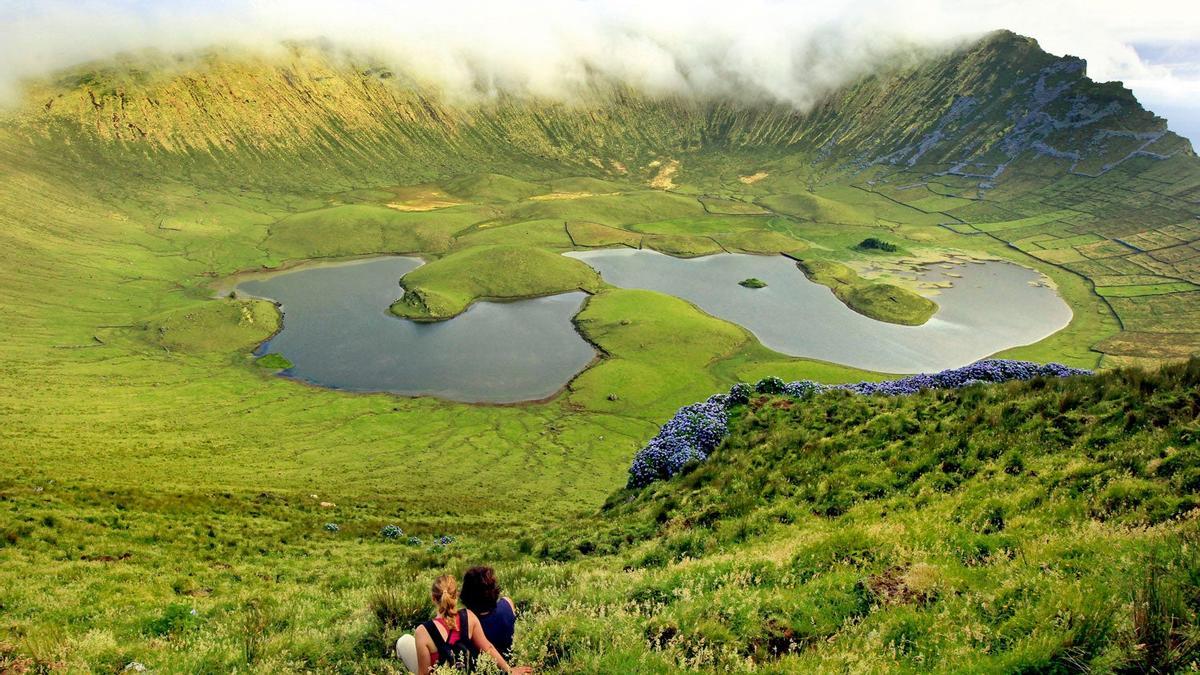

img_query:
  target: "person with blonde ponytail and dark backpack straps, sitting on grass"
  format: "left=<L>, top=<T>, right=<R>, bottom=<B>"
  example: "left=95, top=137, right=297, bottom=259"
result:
left=396, top=574, right=532, bottom=675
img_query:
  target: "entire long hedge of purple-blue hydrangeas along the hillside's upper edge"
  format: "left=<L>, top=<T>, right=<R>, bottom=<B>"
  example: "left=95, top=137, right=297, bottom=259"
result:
left=629, top=359, right=1091, bottom=488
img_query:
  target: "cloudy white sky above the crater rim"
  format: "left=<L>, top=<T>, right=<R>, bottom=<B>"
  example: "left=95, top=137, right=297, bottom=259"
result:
left=0, top=0, right=1200, bottom=145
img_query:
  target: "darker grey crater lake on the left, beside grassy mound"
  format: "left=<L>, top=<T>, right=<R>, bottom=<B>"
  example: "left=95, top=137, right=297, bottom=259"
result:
left=238, top=257, right=595, bottom=402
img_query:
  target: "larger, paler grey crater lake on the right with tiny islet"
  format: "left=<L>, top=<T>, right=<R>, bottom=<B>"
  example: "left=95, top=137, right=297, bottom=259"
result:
left=568, top=249, right=1072, bottom=372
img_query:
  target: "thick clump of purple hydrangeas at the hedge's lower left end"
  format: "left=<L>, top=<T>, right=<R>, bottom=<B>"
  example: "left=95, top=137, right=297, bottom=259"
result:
left=629, top=396, right=729, bottom=488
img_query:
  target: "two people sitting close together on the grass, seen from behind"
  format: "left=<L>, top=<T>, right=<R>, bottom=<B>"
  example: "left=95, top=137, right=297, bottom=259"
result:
left=396, top=566, right=530, bottom=675
